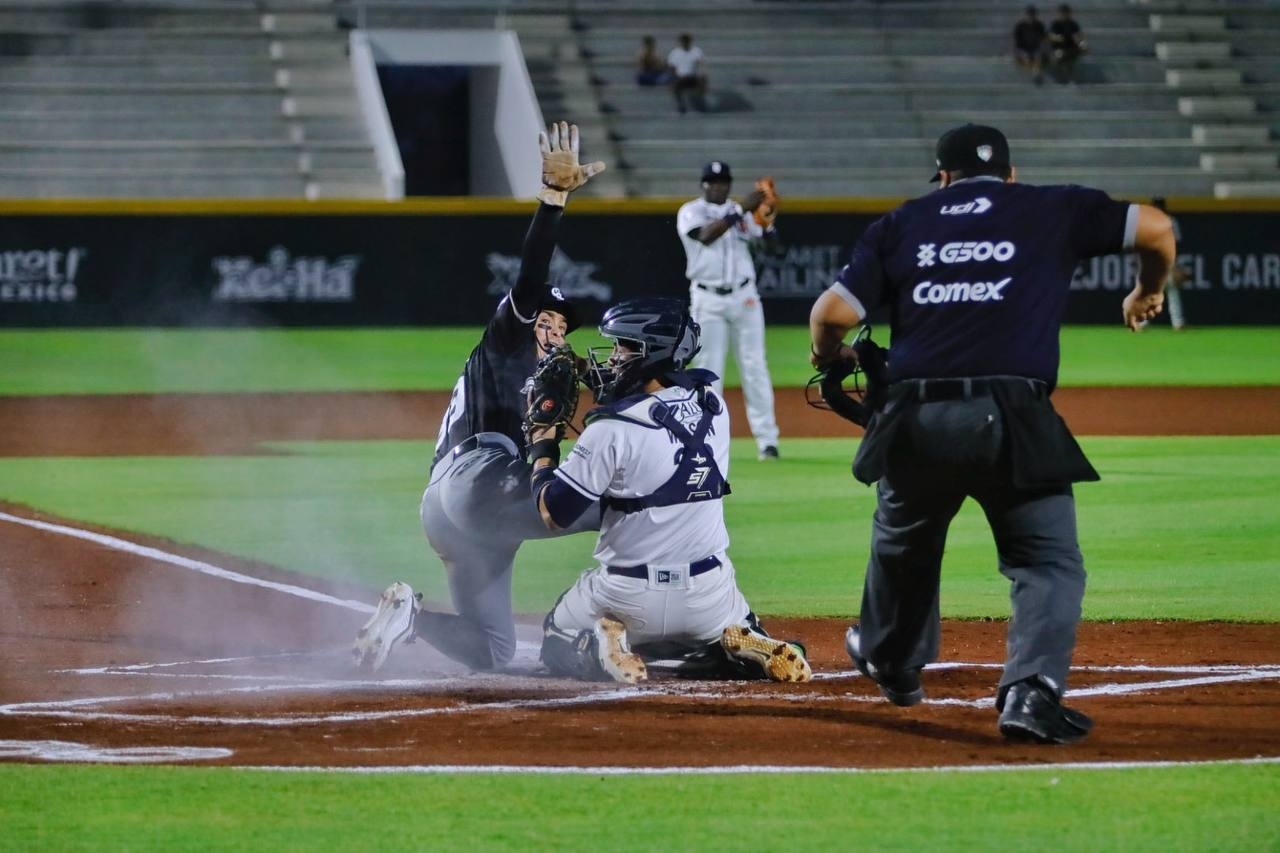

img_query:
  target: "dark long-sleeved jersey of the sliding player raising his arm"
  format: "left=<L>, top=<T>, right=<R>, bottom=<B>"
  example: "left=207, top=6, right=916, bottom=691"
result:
left=433, top=205, right=564, bottom=465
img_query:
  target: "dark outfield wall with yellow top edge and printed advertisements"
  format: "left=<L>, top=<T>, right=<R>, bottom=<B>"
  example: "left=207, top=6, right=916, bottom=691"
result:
left=0, top=199, right=1280, bottom=327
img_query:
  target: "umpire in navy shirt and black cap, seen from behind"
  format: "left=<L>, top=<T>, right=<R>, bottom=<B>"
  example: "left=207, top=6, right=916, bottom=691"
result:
left=809, top=124, right=1175, bottom=743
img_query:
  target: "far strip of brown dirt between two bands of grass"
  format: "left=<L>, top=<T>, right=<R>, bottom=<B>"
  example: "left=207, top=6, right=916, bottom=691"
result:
left=0, top=386, right=1280, bottom=456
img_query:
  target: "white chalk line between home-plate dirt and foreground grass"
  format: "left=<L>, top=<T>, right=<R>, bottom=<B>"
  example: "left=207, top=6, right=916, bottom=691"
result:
left=236, top=756, right=1280, bottom=776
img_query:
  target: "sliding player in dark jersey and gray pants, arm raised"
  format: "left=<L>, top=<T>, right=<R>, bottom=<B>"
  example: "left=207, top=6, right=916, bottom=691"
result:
left=355, top=122, right=604, bottom=670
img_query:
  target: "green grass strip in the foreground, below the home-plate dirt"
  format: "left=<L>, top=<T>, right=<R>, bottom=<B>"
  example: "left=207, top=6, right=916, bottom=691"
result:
left=0, top=766, right=1280, bottom=853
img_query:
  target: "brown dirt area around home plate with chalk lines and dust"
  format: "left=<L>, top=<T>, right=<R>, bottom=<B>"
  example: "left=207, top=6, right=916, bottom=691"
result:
left=0, top=506, right=1280, bottom=767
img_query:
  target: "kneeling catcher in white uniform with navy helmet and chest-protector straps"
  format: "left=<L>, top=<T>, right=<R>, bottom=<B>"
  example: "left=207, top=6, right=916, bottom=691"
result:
left=530, top=298, right=812, bottom=683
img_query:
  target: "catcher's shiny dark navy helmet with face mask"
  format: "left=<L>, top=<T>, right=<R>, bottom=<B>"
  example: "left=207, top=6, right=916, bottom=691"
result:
left=589, top=297, right=701, bottom=403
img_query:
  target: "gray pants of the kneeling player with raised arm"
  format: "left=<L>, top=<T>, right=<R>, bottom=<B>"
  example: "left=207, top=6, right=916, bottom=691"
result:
left=421, top=433, right=600, bottom=666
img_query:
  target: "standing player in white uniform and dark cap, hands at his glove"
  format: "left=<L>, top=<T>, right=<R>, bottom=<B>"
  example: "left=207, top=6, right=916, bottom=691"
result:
left=676, top=160, right=778, bottom=460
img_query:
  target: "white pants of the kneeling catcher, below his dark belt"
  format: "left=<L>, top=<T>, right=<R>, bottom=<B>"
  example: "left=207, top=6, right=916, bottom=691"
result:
left=553, top=553, right=750, bottom=648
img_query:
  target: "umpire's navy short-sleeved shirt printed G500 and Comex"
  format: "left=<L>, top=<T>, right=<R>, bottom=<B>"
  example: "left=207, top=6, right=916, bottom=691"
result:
left=832, top=177, right=1138, bottom=387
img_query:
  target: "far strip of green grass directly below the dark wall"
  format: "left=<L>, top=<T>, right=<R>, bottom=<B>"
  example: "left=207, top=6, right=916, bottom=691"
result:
left=0, top=324, right=1280, bottom=396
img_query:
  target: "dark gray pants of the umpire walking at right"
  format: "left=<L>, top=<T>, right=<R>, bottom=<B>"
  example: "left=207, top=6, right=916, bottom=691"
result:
left=859, top=397, right=1084, bottom=695
